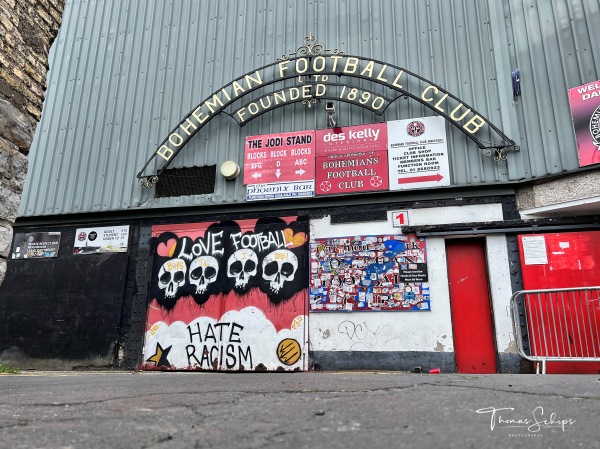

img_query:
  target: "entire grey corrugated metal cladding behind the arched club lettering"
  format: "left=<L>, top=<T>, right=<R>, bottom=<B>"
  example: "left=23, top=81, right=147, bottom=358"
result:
left=21, top=0, right=600, bottom=216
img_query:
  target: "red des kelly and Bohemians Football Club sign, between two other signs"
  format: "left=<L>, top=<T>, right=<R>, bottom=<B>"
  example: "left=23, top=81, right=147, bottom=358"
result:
left=315, top=123, right=388, bottom=195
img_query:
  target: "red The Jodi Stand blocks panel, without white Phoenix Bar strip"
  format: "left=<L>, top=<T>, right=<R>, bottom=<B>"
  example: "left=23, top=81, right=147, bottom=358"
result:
left=244, top=131, right=315, bottom=184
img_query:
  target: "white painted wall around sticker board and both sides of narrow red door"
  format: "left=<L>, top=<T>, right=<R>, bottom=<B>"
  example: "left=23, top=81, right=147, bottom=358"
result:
left=308, top=204, right=516, bottom=352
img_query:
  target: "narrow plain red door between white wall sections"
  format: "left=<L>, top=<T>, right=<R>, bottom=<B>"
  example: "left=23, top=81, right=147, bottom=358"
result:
left=446, top=239, right=496, bottom=374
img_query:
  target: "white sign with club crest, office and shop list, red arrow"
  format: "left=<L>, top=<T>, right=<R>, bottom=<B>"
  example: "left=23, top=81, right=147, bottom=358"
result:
left=388, top=117, right=450, bottom=190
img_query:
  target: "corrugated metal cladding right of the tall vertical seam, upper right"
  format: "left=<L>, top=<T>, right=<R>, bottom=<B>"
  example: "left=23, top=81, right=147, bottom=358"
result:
left=498, top=0, right=600, bottom=178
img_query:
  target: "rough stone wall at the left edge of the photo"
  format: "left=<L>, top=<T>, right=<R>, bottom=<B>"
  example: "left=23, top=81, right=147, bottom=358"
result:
left=0, top=0, right=64, bottom=283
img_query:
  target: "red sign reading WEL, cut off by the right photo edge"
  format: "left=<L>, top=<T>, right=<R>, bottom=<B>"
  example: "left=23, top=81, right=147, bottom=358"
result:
left=569, top=81, right=600, bottom=167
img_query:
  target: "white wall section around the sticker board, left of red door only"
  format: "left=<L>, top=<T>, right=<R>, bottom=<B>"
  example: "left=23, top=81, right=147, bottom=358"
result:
left=308, top=214, right=454, bottom=352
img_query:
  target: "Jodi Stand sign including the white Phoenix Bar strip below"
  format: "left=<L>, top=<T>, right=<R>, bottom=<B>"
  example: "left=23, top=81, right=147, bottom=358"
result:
left=244, top=131, right=315, bottom=201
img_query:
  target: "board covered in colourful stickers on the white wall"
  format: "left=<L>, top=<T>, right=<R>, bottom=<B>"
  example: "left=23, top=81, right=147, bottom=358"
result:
left=309, top=235, right=430, bottom=312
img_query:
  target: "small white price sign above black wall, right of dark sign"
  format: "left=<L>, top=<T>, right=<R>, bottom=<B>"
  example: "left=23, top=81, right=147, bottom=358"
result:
left=73, top=226, right=129, bottom=254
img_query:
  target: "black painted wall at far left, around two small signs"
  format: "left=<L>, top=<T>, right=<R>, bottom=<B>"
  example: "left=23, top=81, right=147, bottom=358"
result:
left=0, top=222, right=136, bottom=369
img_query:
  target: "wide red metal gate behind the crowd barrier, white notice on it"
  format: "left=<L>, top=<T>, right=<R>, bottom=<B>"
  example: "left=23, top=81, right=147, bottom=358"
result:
left=519, top=231, right=600, bottom=374
